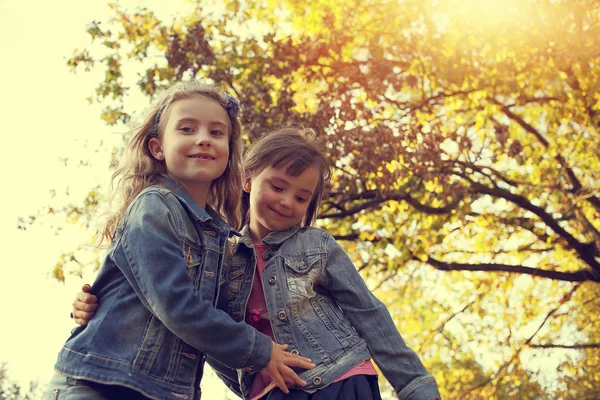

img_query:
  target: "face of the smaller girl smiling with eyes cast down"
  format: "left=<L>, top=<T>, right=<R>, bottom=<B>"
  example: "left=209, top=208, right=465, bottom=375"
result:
left=244, top=165, right=320, bottom=241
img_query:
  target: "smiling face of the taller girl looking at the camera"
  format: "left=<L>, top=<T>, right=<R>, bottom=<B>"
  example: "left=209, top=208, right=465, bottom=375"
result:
left=149, top=95, right=230, bottom=205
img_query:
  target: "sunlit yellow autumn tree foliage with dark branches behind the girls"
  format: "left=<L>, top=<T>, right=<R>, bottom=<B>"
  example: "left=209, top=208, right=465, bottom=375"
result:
left=22, top=0, right=600, bottom=399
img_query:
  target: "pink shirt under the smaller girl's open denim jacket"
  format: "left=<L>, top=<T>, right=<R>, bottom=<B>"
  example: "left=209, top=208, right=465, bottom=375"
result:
left=246, top=243, right=377, bottom=400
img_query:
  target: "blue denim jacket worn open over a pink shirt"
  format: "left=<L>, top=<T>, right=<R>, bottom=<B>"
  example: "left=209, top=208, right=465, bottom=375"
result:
left=209, top=226, right=440, bottom=400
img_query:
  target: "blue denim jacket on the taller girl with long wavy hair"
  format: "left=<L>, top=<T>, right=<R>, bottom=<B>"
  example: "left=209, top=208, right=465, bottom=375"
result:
left=55, top=179, right=271, bottom=399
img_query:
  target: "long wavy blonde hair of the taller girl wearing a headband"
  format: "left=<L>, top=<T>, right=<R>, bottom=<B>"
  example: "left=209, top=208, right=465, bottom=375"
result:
left=100, top=81, right=243, bottom=243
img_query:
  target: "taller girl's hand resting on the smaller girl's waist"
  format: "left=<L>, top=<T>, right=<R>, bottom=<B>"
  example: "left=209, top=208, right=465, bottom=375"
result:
left=265, top=342, right=315, bottom=394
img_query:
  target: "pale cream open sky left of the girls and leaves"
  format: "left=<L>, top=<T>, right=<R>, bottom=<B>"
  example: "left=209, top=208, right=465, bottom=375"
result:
left=0, top=0, right=233, bottom=399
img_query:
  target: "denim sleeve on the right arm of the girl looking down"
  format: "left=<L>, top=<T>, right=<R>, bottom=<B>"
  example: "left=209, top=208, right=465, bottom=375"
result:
left=324, top=234, right=440, bottom=400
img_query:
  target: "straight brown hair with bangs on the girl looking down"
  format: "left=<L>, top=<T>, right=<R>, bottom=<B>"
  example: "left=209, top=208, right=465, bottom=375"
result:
left=242, top=126, right=331, bottom=226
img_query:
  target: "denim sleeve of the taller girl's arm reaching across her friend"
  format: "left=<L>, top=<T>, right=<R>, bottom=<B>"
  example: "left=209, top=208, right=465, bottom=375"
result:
left=113, top=192, right=271, bottom=369
